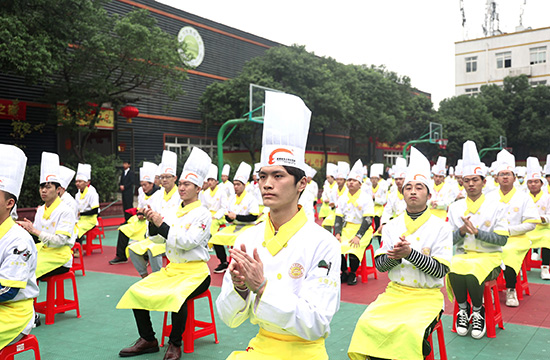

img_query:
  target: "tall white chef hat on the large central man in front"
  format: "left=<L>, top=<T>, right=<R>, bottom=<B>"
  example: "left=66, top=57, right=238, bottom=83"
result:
left=260, top=91, right=311, bottom=171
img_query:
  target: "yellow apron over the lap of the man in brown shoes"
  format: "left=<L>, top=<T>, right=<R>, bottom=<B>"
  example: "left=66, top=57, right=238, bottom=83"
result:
left=116, top=261, right=210, bottom=312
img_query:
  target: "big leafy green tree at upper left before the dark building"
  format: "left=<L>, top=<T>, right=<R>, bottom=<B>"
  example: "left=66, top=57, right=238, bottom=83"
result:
left=0, top=0, right=187, bottom=161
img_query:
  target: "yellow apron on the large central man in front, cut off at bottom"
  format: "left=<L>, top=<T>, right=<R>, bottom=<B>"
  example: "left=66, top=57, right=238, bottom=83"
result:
left=227, top=328, right=328, bottom=360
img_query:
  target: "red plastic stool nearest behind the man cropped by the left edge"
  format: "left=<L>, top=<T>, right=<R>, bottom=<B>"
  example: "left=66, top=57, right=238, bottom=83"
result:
left=34, top=270, right=80, bottom=325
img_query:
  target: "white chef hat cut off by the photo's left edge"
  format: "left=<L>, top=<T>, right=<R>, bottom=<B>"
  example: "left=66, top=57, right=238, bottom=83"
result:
left=0, top=144, right=27, bottom=198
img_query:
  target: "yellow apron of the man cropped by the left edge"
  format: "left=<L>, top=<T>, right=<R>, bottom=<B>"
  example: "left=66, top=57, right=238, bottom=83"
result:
left=0, top=299, right=34, bottom=350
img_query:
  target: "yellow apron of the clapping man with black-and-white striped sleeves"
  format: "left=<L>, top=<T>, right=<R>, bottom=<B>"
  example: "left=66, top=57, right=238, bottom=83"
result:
left=348, top=282, right=443, bottom=360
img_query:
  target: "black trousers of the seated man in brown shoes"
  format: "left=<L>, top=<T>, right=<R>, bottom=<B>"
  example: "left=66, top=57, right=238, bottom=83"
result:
left=134, top=275, right=210, bottom=347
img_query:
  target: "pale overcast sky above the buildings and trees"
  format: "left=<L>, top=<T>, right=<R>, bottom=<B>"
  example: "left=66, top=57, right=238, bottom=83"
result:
left=159, top=0, right=550, bottom=109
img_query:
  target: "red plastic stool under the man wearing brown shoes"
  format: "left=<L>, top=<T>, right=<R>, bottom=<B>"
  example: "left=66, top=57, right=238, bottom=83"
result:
left=160, top=290, right=219, bottom=353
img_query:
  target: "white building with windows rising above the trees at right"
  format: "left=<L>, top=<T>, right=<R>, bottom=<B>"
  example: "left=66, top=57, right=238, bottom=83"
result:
left=455, top=27, right=550, bottom=96
